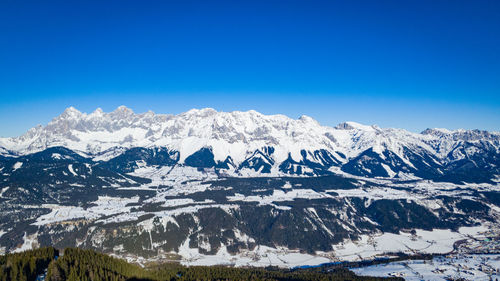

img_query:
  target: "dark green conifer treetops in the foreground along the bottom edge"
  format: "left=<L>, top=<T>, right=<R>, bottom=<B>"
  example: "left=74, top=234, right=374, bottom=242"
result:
left=0, top=247, right=398, bottom=281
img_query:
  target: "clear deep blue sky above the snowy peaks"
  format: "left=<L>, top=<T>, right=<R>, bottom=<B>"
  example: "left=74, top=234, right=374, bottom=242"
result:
left=0, top=0, right=500, bottom=136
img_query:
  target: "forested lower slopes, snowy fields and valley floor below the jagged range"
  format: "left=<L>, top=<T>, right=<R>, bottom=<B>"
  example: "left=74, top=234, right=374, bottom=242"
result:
left=0, top=160, right=500, bottom=267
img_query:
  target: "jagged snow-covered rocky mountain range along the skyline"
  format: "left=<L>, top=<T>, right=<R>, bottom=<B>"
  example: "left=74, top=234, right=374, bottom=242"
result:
left=0, top=106, right=500, bottom=182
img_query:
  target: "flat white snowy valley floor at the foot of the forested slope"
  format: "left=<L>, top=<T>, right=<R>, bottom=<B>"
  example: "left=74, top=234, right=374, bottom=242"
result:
left=118, top=223, right=496, bottom=266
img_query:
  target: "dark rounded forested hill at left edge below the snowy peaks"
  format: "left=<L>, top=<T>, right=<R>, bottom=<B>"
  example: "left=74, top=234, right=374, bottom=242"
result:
left=0, top=144, right=151, bottom=204
